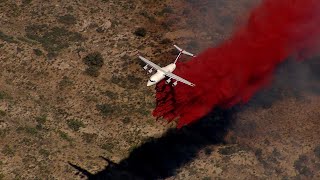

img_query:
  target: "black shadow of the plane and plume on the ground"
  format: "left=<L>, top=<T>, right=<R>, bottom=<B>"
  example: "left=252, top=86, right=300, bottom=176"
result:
left=69, top=109, right=235, bottom=180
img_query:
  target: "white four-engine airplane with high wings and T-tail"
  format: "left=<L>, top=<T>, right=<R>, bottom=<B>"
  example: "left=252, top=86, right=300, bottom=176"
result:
left=139, top=45, right=196, bottom=87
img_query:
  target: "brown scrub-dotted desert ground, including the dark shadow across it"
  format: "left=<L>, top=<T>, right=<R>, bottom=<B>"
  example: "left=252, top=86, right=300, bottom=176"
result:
left=0, top=0, right=320, bottom=180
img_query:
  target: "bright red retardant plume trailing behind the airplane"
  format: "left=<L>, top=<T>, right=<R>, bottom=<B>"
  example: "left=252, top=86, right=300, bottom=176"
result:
left=153, top=0, right=320, bottom=128
